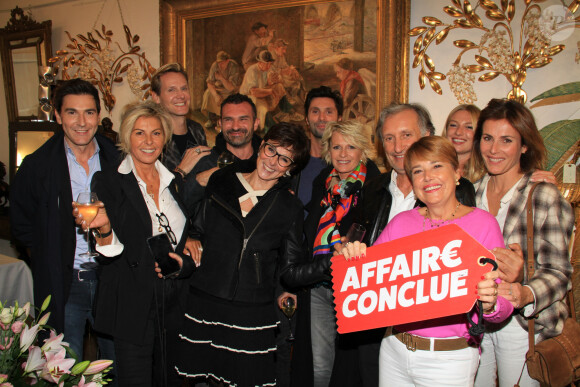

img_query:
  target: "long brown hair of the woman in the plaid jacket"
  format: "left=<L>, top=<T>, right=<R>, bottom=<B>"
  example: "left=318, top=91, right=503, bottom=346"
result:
left=472, top=98, right=548, bottom=173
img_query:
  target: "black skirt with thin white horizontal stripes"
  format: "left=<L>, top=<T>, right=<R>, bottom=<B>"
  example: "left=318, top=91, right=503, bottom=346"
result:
left=173, top=292, right=279, bottom=387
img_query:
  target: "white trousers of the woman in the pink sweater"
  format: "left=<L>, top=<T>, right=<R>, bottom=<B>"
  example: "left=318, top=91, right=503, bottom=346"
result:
left=379, top=336, right=479, bottom=387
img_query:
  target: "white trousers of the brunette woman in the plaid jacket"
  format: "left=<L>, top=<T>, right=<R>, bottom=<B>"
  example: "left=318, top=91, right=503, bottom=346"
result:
left=475, top=316, right=540, bottom=387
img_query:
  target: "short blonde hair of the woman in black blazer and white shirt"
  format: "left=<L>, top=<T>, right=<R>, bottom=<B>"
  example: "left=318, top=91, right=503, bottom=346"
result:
left=118, top=101, right=173, bottom=154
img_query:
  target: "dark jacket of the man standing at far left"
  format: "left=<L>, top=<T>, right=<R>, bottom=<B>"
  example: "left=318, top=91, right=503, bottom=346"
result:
left=10, top=131, right=120, bottom=332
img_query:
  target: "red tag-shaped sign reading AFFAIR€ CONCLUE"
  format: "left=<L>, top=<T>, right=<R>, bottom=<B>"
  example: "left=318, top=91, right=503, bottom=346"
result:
left=332, top=224, right=495, bottom=333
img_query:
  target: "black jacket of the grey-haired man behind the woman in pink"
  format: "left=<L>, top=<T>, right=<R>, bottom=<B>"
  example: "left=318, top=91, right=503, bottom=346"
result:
left=353, top=172, right=475, bottom=246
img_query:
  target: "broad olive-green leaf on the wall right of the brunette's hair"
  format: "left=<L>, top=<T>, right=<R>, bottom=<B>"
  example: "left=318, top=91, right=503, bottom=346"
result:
left=540, top=119, right=580, bottom=171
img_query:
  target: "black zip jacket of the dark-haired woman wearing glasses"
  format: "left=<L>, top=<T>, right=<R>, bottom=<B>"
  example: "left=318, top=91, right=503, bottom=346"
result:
left=190, top=160, right=303, bottom=303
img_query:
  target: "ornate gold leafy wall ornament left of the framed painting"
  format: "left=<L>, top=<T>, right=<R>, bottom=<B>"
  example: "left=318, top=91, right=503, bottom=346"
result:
left=49, top=25, right=155, bottom=112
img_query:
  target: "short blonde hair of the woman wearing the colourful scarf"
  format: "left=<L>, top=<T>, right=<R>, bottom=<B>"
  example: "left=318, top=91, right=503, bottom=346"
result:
left=322, top=120, right=375, bottom=164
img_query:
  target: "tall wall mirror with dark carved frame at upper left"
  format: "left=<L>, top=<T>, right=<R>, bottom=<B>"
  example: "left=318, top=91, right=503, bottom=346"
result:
left=0, top=7, right=52, bottom=122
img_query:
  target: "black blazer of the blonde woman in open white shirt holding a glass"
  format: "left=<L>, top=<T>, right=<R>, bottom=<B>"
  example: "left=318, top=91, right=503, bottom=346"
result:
left=92, top=171, right=193, bottom=344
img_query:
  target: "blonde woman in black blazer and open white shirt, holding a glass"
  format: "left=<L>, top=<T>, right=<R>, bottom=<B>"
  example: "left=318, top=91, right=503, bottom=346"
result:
left=73, top=102, right=193, bottom=386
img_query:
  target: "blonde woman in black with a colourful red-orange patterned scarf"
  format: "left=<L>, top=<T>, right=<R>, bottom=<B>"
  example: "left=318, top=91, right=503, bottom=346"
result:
left=285, top=121, right=380, bottom=387
